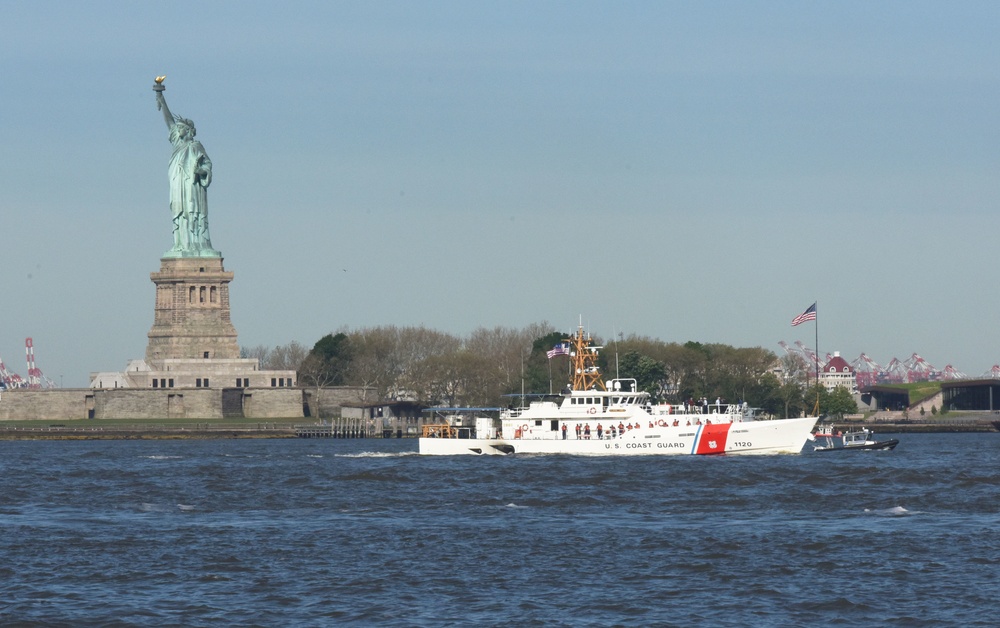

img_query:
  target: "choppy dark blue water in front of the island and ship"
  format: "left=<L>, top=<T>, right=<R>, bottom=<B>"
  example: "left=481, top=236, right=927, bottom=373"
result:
left=0, top=434, right=1000, bottom=626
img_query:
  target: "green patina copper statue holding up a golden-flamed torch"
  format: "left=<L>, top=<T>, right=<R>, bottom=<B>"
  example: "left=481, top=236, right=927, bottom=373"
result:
left=153, top=76, right=222, bottom=257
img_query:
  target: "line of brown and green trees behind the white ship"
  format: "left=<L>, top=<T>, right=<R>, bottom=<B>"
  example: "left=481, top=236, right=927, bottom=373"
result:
left=241, top=322, right=857, bottom=417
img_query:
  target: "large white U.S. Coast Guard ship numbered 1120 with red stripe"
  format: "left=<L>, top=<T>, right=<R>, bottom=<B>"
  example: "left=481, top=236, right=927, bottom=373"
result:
left=419, top=328, right=817, bottom=456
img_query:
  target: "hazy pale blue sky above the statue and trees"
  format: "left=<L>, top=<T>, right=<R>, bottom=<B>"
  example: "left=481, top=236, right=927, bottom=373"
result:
left=0, top=0, right=1000, bottom=387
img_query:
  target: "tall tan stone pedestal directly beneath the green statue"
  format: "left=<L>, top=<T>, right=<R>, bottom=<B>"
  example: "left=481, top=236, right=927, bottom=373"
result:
left=146, top=257, right=240, bottom=370
